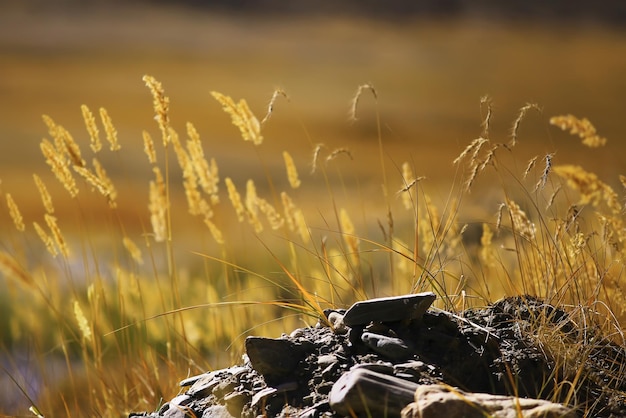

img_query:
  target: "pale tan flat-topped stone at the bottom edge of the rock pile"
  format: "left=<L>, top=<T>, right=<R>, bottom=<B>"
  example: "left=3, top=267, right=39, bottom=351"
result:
left=402, top=385, right=577, bottom=418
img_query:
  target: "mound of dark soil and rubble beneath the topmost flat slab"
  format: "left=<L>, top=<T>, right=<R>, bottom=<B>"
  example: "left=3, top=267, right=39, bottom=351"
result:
left=130, top=297, right=626, bottom=418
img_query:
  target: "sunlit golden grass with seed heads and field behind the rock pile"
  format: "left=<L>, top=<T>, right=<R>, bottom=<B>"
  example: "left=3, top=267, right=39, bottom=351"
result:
left=0, top=5, right=626, bottom=416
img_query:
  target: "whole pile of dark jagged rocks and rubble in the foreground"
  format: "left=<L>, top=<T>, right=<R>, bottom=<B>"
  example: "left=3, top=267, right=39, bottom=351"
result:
left=130, top=292, right=626, bottom=418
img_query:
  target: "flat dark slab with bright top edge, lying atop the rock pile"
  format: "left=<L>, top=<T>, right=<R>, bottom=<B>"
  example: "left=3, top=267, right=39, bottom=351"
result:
left=343, top=292, right=436, bottom=327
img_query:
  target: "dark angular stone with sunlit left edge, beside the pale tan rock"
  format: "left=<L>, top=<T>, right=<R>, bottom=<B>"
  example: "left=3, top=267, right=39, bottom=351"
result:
left=328, top=368, right=418, bottom=417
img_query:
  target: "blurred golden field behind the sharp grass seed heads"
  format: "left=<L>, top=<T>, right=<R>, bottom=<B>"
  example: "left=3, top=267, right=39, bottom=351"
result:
left=0, top=4, right=626, bottom=416
